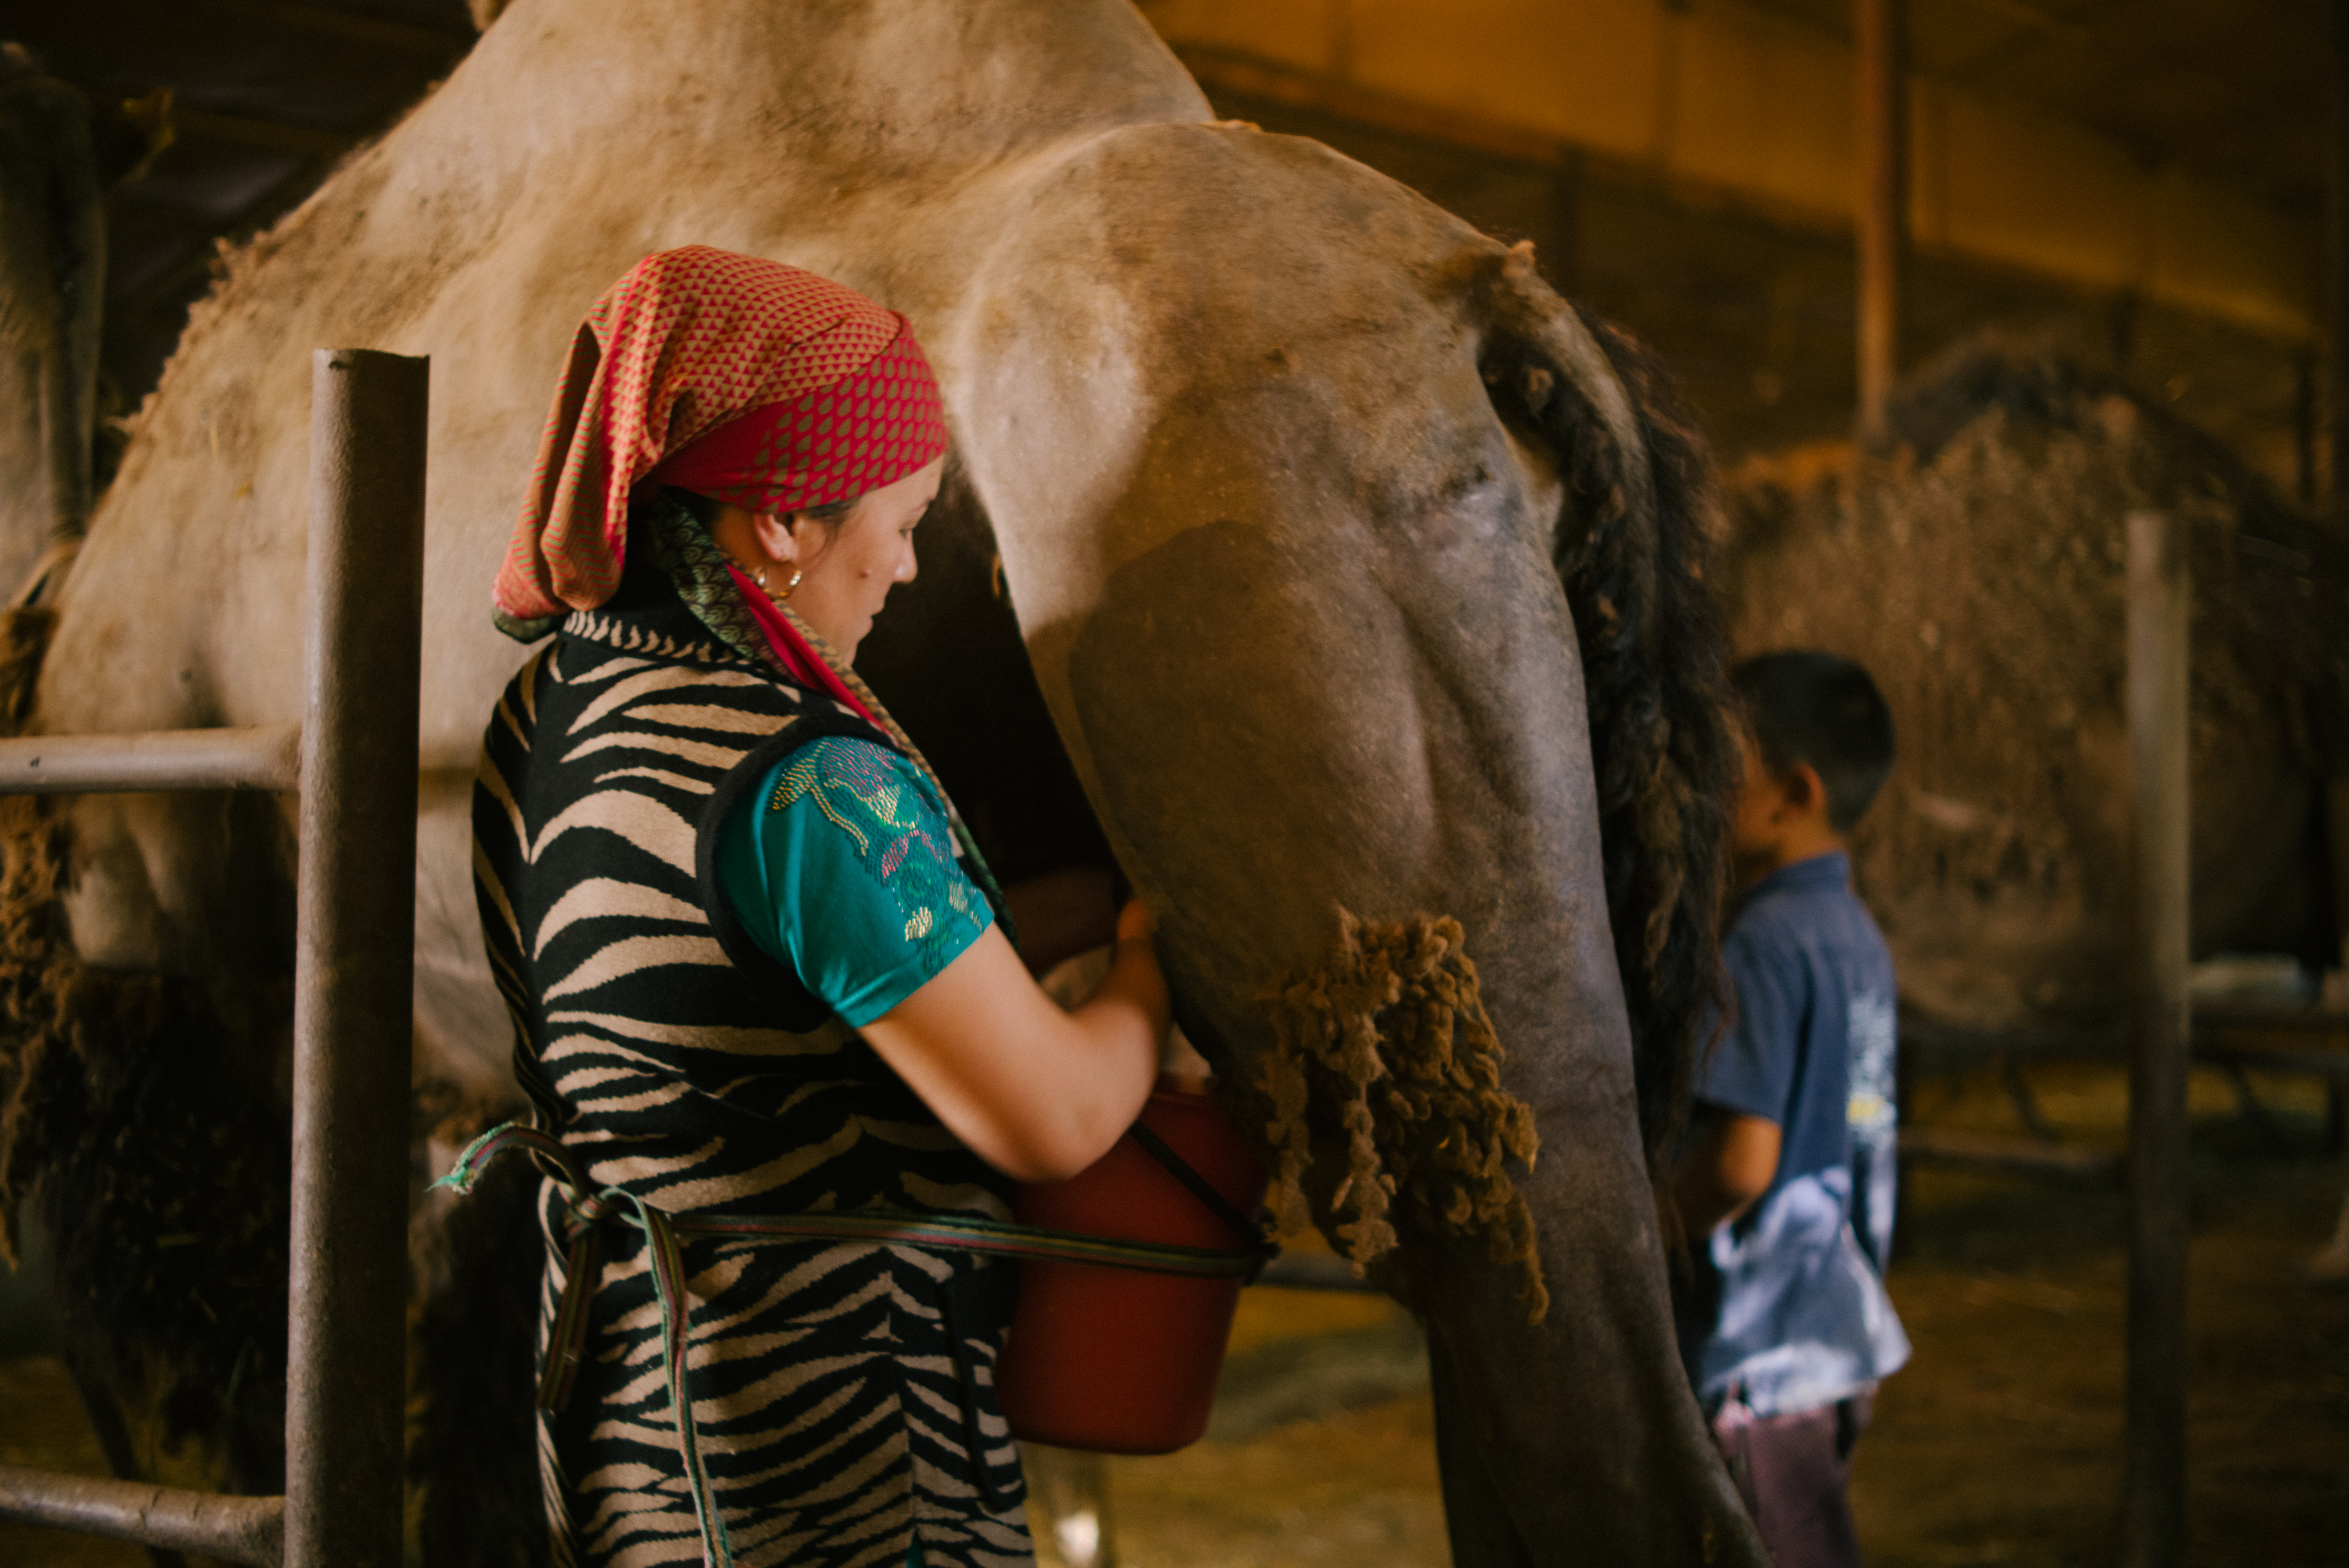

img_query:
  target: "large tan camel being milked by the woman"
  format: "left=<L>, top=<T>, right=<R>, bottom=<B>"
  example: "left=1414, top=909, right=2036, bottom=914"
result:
left=0, top=0, right=1764, bottom=1568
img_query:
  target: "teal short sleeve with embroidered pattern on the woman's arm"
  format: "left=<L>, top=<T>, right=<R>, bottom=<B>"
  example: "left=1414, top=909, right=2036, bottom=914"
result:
left=719, top=735, right=994, bottom=1028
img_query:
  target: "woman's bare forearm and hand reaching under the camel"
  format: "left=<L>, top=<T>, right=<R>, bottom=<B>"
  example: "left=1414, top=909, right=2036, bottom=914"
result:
left=862, top=901, right=1167, bottom=1181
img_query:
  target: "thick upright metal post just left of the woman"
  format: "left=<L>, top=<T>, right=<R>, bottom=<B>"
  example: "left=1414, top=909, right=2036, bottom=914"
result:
left=284, top=350, right=427, bottom=1568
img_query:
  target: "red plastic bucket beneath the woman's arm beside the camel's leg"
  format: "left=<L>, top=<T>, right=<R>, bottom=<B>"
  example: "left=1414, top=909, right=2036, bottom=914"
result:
left=996, top=1077, right=1264, bottom=1453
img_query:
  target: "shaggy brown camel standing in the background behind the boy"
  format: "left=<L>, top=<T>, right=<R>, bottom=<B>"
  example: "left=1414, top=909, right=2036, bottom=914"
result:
left=1722, top=343, right=2349, bottom=1026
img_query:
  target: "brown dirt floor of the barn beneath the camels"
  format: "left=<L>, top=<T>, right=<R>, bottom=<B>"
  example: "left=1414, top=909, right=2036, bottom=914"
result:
left=0, top=1066, right=2349, bottom=1568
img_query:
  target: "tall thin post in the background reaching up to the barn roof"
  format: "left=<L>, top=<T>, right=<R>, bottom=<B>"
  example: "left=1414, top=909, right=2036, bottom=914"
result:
left=1856, top=0, right=1907, bottom=441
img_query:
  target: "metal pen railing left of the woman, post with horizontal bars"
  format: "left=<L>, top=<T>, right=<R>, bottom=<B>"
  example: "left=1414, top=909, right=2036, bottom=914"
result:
left=0, top=350, right=430, bottom=1568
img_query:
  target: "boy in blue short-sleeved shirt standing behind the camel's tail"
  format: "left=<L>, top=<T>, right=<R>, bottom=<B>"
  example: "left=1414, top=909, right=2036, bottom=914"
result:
left=1673, top=653, right=1910, bottom=1568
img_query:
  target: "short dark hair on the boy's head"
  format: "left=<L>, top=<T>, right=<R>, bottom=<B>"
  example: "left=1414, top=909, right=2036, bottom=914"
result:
left=1729, top=648, right=1893, bottom=833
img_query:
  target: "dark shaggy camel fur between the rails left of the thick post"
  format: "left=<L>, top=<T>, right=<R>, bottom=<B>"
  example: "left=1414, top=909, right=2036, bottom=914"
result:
left=0, top=796, right=291, bottom=1493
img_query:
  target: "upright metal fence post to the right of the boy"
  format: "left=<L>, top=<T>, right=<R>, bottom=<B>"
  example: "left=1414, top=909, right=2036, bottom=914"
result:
left=2121, top=512, right=2194, bottom=1568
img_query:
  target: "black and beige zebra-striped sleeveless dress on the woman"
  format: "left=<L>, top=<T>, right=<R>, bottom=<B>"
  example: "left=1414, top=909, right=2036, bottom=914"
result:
left=474, top=580, right=1029, bottom=1568
